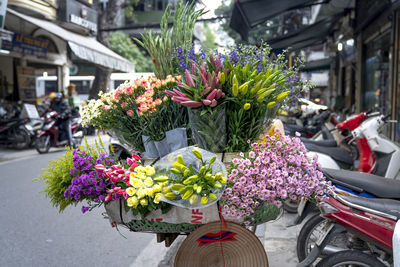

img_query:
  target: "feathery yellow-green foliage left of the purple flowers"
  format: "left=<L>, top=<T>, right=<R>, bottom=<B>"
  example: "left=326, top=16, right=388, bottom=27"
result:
left=34, top=148, right=78, bottom=212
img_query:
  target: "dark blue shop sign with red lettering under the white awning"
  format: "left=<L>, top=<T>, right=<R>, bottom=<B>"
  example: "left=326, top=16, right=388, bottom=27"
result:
left=1, top=33, right=49, bottom=56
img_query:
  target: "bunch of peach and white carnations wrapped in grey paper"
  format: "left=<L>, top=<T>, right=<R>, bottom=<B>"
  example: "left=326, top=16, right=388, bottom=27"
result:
left=82, top=75, right=187, bottom=158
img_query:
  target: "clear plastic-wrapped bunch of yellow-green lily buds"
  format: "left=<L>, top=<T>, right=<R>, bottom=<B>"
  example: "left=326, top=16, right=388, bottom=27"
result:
left=154, top=146, right=227, bottom=208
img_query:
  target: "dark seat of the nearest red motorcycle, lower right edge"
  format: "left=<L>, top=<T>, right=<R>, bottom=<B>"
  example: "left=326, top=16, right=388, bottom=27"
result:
left=341, top=196, right=400, bottom=220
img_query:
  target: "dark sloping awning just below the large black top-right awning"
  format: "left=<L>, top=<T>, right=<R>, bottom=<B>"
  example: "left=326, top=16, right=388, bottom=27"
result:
left=267, top=17, right=337, bottom=50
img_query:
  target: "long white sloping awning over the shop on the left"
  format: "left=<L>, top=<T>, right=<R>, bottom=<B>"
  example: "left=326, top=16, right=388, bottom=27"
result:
left=7, top=8, right=135, bottom=72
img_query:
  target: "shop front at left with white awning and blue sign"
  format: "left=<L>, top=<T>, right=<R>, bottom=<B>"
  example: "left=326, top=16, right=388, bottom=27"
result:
left=0, top=6, right=134, bottom=102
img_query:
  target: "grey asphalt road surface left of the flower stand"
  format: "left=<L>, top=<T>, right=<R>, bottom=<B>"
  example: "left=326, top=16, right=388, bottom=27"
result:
left=0, top=151, right=155, bottom=267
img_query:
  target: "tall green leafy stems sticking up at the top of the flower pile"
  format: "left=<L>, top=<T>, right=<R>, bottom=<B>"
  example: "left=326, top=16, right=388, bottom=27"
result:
left=135, top=2, right=205, bottom=78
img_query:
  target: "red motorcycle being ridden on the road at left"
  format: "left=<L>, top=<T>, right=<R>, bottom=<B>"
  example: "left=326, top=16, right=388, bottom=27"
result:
left=35, top=111, right=83, bottom=154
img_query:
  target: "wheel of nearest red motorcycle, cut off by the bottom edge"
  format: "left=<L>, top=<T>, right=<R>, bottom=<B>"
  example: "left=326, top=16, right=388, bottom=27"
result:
left=316, top=250, right=385, bottom=267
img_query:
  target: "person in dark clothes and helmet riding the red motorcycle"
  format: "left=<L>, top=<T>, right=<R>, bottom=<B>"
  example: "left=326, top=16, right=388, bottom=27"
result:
left=50, top=93, right=72, bottom=147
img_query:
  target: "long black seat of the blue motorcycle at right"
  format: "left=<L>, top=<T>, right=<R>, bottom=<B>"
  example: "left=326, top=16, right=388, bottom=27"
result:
left=322, top=168, right=400, bottom=200
